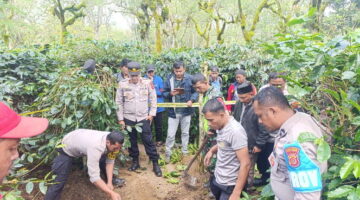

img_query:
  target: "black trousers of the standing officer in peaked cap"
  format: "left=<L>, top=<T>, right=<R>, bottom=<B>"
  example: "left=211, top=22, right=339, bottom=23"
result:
left=124, top=119, right=159, bottom=161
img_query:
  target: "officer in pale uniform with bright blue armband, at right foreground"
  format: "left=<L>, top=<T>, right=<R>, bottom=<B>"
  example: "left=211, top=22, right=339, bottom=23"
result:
left=253, top=86, right=327, bottom=200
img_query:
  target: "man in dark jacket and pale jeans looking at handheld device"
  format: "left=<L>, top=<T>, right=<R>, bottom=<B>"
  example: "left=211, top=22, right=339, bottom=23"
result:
left=163, top=62, right=198, bottom=161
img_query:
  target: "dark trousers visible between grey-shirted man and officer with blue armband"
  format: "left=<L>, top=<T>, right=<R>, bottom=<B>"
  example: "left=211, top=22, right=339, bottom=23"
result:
left=256, top=142, right=274, bottom=181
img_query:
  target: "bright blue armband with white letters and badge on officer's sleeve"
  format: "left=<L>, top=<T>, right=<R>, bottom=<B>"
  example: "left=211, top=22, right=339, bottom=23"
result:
left=284, top=142, right=322, bottom=192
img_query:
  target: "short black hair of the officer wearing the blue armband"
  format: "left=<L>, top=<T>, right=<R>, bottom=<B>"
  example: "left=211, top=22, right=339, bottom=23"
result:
left=254, top=86, right=291, bottom=109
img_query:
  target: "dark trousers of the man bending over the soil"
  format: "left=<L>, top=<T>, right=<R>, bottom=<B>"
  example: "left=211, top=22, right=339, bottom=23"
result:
left=44, top=149, right=106, bottom=200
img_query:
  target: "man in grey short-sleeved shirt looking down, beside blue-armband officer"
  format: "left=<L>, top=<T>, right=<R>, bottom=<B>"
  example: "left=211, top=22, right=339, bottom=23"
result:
left=202, top=98, right=250, bottom=200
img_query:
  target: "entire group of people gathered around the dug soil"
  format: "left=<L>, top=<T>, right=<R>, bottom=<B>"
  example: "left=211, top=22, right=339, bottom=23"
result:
left=0, top=59, right=327, bottom=200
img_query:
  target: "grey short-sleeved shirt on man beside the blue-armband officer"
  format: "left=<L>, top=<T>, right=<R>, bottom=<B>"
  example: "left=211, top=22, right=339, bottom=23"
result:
left=215, top=117, right=247, bottom=186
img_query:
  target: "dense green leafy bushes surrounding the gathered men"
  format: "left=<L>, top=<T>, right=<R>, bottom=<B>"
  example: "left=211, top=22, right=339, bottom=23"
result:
left=0, top=29, right=360, bottom=199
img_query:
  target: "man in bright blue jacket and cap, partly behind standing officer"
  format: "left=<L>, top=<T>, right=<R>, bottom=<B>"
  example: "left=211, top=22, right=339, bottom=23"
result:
left=145, top=65, right=165, bottom=147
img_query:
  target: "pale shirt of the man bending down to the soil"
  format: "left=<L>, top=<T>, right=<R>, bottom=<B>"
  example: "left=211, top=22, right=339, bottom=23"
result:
left=62, top=129, right=114, bottom=183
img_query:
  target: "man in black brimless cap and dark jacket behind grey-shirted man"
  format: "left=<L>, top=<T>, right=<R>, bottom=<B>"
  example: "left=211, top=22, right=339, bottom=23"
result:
left=234, top=82, right=269, bottom=189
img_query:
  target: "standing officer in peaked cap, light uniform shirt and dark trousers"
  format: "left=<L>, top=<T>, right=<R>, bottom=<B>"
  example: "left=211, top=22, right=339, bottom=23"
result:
left=116, top=62, right=162, bottom=177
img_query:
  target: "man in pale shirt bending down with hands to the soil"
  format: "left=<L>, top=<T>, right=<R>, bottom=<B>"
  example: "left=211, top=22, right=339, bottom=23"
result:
left=45, top=129, right=124, bottom=200
